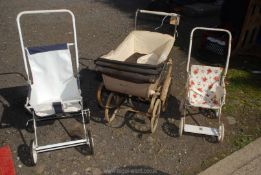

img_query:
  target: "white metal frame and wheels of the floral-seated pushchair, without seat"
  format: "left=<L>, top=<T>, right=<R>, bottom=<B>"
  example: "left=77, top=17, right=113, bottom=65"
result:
left=179, top=27, right=232, bottom=142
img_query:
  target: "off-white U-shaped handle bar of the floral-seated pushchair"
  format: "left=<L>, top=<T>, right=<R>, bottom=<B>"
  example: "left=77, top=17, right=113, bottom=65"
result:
left=187, top=27, right=232, bottom=76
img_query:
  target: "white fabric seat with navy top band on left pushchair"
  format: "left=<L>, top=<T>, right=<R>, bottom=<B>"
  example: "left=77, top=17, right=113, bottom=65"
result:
left=27, top=44, right=82, bottom=117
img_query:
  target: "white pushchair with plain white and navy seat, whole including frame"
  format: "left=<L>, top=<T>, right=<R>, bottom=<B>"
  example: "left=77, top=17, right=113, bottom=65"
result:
left=16, top=9, right=93, bottom=164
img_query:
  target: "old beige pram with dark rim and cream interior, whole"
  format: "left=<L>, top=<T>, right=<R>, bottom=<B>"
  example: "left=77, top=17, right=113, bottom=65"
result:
left=95, top=10, right=180, bottom=132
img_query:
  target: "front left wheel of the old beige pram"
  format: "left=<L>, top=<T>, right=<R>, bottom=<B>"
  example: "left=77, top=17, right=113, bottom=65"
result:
left=104, top=92, right=124, bottom=123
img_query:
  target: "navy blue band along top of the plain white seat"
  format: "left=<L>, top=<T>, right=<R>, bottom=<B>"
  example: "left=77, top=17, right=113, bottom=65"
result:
left=27, top=43, right=68, bottom=55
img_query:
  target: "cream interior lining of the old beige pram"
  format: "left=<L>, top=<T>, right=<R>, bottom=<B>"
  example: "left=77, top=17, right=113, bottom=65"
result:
left=101, top=30, right=175, bottom=65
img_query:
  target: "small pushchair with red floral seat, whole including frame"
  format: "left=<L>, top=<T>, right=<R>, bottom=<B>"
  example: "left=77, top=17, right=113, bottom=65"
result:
left=179, top=27, right=232, bottom=142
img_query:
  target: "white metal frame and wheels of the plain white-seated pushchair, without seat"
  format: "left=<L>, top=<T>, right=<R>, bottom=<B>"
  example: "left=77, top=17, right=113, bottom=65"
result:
left=16, top=9, right=93, bottom=165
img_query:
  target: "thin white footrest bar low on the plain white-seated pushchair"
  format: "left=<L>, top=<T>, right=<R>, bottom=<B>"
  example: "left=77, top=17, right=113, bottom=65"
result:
left=35, top=139, right=89, bottom=153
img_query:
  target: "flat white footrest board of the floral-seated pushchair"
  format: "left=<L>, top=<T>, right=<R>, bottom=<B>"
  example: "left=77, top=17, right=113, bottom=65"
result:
left=184, top=124, right=220, bottom=136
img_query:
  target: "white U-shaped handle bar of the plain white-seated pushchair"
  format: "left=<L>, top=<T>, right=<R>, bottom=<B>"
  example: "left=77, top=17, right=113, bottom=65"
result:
left=16, top=9, right=79, bottom=80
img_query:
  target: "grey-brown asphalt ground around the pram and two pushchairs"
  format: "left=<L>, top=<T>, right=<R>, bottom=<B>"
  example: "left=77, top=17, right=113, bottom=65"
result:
left=0, top=0, right=229, bottom=175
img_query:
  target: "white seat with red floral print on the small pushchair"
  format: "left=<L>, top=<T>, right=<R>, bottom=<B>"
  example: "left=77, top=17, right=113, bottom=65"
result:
left=188, top=65, right=225, bottom=109
